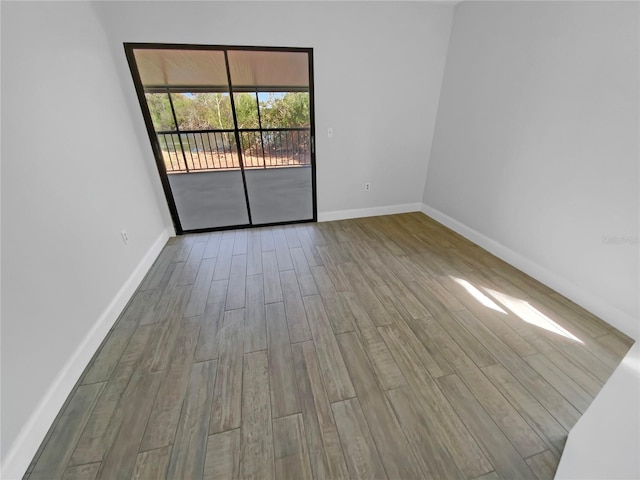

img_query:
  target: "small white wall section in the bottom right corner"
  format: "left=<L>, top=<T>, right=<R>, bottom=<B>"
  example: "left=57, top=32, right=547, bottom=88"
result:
left=555, top=343, right=640, bottom=480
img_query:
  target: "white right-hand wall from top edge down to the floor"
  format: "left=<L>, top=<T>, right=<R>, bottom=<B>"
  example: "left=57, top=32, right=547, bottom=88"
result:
left=424, top=2, right=640, bottom=338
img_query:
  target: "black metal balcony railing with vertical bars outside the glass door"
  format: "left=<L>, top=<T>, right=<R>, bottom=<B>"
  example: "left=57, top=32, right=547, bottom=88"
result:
left=156, top=128, right=311, bottom=173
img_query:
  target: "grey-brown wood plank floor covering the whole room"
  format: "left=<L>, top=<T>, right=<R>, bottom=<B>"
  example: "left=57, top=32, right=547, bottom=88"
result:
left=25, top=213, right=632, bottom=480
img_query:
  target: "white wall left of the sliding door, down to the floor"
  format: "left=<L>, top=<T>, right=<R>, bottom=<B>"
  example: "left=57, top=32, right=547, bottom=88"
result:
left=2, top=2, right=167, bottom=478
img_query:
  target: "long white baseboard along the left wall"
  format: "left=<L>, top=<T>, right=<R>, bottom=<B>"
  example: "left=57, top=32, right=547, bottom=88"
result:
left=0, top=230, right=172, bottom=480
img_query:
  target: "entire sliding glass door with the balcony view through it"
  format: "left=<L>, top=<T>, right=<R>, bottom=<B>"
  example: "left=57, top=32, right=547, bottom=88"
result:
left=125, top=43, right=317, bottom=234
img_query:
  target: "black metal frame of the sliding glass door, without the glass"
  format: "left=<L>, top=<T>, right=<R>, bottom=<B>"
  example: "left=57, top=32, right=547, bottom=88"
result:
left=124, top=42, right=318, bottom=235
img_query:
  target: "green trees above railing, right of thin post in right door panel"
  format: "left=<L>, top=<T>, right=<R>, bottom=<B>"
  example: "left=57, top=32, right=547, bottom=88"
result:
left=258, top=92, right=311, bottom=128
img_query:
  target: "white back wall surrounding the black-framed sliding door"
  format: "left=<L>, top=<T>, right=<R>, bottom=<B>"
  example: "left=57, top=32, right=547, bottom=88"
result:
left=97, top=2, right=453, bottom=220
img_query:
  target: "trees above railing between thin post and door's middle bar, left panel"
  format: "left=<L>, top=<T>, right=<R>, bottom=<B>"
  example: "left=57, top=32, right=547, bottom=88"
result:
left=171, top=92, right=233, bottom=130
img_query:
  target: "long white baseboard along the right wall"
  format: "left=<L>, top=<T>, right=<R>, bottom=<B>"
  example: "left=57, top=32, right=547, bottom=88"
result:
left=420, top=204, right=640, bottom=340
